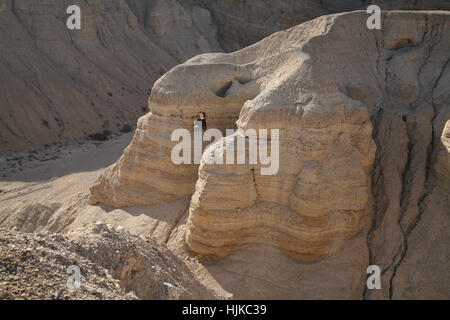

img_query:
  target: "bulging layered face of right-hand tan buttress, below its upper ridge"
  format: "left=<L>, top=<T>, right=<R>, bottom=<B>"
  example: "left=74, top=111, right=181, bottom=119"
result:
left=187, top=92, right=375, bottom=260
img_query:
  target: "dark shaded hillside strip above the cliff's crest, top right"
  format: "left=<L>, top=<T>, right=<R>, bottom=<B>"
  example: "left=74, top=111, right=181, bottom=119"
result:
left=198, top=0, right=450, bottom=52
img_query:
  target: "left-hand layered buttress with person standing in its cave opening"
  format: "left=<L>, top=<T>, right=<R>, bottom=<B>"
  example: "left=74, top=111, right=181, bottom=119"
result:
left=90, top=64, right=257, bottom=207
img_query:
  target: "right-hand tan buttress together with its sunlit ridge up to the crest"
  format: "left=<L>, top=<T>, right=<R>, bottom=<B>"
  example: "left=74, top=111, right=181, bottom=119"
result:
left=186, top=15, right=376, bottom=260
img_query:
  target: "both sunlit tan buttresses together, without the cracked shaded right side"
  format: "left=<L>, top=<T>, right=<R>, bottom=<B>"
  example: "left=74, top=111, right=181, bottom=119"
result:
left=90, top=12, right=382, bottom=260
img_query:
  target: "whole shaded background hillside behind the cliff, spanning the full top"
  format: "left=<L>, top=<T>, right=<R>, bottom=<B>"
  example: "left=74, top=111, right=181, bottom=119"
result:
left=0, top=0, right=450, bottom=153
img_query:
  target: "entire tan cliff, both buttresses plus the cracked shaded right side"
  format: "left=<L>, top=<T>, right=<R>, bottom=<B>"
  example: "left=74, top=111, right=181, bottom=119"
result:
left=91, top=12, right=450, bottom=299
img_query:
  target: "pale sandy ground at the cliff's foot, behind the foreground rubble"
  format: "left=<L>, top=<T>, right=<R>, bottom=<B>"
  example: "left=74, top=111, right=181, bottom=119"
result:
left=0, top=133, right=357, bottom=299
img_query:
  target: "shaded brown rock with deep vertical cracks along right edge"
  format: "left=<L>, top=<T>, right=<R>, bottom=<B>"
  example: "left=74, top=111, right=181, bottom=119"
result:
left=364, top=12, right=450, bottom=299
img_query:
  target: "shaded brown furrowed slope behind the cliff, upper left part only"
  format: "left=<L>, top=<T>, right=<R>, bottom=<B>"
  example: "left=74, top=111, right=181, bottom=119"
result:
left=0, top=0, right=221, bottom=151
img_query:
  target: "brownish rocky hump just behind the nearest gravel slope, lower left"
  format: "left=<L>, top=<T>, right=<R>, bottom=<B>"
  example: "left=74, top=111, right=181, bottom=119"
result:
left=67, top=221, right=218, bottom=300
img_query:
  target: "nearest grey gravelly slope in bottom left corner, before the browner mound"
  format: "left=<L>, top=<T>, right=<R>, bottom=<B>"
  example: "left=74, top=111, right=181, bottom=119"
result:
left=0, top=228, right=137, bottom=300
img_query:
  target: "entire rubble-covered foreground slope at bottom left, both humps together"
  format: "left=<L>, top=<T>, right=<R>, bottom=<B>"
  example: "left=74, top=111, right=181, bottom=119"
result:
left=0, top=222, right=215, bottom=300
